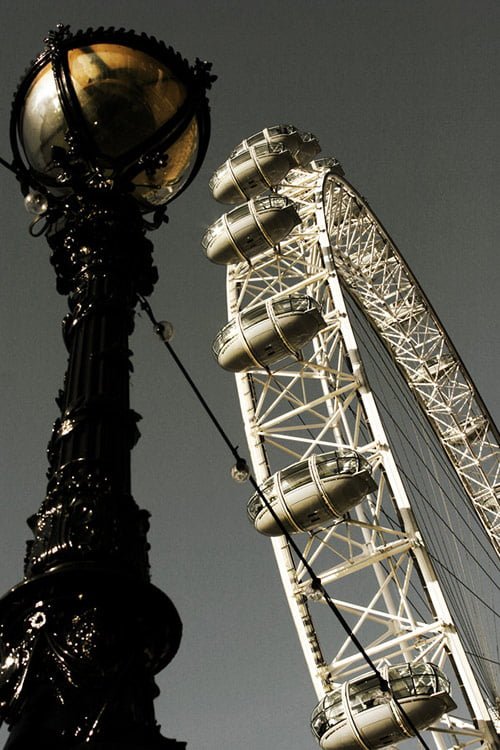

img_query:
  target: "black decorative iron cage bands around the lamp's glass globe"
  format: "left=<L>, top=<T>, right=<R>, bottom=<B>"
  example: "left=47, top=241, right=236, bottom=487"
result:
left=9, top=24, right=216, bottom=228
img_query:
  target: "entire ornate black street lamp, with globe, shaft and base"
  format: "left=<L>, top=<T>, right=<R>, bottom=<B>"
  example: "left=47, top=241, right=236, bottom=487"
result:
left=0, top=26, right=213, bottom=750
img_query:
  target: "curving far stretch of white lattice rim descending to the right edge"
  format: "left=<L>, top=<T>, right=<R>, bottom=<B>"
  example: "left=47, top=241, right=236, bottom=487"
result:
left=324, top=175, right=500, bottom=552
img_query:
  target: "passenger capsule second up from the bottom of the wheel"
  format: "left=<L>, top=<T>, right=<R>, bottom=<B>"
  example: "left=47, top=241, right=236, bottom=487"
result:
left=247, top=449, right=376, bottom=536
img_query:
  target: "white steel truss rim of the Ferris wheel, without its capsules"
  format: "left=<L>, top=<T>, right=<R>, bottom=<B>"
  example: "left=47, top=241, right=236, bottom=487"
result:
left=227, top=163, right=499, bottom=750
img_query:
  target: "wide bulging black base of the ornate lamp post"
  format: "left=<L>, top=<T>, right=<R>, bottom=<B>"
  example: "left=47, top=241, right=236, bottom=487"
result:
left=0, top=564, right=185, bottom=750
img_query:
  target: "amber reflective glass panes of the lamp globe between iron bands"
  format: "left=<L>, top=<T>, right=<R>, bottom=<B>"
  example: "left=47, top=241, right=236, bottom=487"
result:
left=19, top=42, right=199, bottom=206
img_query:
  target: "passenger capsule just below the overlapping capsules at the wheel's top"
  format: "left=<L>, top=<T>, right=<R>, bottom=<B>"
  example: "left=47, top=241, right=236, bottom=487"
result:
left=201, top=195, right=301, bottom=265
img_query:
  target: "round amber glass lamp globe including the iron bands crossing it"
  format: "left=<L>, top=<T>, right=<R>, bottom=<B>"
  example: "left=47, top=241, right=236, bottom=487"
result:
left=12, top=32, right=208, bottom=210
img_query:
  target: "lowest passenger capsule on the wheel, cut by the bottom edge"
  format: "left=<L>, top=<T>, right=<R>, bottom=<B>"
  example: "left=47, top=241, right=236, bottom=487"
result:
left=311, top=662, right=456, bottom=750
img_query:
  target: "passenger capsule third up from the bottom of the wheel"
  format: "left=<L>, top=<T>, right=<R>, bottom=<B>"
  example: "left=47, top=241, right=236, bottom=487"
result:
left=212, top=294, right=326, bottom=372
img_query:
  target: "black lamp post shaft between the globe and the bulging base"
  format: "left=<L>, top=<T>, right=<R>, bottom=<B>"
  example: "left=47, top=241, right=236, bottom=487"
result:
left=25, top=194, right=156, bottom=581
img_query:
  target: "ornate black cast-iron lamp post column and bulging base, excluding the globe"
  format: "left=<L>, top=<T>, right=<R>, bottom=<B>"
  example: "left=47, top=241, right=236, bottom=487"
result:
left=0, top=172, right=184, bottom=750
